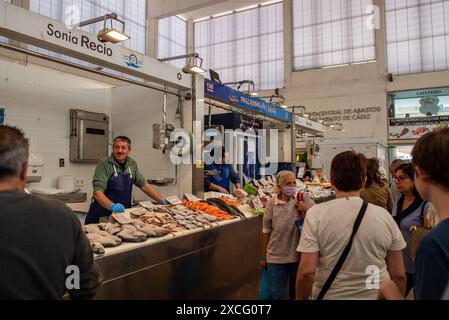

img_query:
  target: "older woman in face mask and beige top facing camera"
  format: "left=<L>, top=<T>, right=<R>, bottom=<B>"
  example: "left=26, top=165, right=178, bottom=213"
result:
left=261, top=171, right=300, bottom=300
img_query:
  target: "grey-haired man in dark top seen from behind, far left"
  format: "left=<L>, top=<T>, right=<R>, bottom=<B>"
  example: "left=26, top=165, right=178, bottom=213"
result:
left=0, top=126, right=101, bottom=300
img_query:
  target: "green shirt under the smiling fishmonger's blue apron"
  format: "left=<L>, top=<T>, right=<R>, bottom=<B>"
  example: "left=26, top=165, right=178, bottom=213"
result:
left=92, top=155, right=147, bottom=192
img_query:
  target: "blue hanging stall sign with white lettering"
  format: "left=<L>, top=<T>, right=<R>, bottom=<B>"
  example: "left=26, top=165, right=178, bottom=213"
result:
left=204, top=79, right=292, bottom=122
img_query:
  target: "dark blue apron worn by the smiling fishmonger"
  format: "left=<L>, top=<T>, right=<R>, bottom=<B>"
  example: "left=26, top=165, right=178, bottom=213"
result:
left=84, top=165, right=133, bottom=224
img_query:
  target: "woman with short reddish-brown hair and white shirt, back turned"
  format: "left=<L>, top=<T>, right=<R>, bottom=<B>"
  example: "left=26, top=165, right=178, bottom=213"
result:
left=297, top=151, right=406, bottom=300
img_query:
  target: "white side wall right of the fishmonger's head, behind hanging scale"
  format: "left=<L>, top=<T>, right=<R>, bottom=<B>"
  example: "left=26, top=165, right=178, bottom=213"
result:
left=112, top=86, right=192, bottom=200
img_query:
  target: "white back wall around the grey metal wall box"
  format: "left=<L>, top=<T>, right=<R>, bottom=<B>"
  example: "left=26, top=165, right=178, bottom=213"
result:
left=0, top=59, right=111, bottom=198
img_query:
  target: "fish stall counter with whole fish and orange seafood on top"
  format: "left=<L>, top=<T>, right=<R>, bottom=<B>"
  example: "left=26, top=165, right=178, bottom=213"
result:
left=84, top=195, right=262, bottom=299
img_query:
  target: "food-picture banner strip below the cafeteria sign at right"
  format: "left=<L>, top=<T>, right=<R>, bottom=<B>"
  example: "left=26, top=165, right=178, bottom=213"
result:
left=389, top=116, right=449, bottom=140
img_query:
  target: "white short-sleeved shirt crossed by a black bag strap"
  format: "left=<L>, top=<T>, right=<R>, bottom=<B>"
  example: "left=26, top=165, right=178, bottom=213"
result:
left=297, top=197, right=406, bottom=300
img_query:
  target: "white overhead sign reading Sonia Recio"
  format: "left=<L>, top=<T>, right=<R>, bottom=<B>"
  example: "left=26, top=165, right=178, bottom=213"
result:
left=0, top=1, right=192, bottom=89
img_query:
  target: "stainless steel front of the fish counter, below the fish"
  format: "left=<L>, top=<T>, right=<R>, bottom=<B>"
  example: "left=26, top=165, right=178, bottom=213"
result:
left=96, top=217, right=262, bottom=299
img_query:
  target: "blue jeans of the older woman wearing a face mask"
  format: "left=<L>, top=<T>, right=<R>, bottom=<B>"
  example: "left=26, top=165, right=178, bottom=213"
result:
left=267, top=263, right=299, bottom=300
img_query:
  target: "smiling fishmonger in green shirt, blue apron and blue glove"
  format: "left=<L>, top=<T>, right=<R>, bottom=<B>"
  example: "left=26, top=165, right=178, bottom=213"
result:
left=85, top=136, right=167, bottom=224
